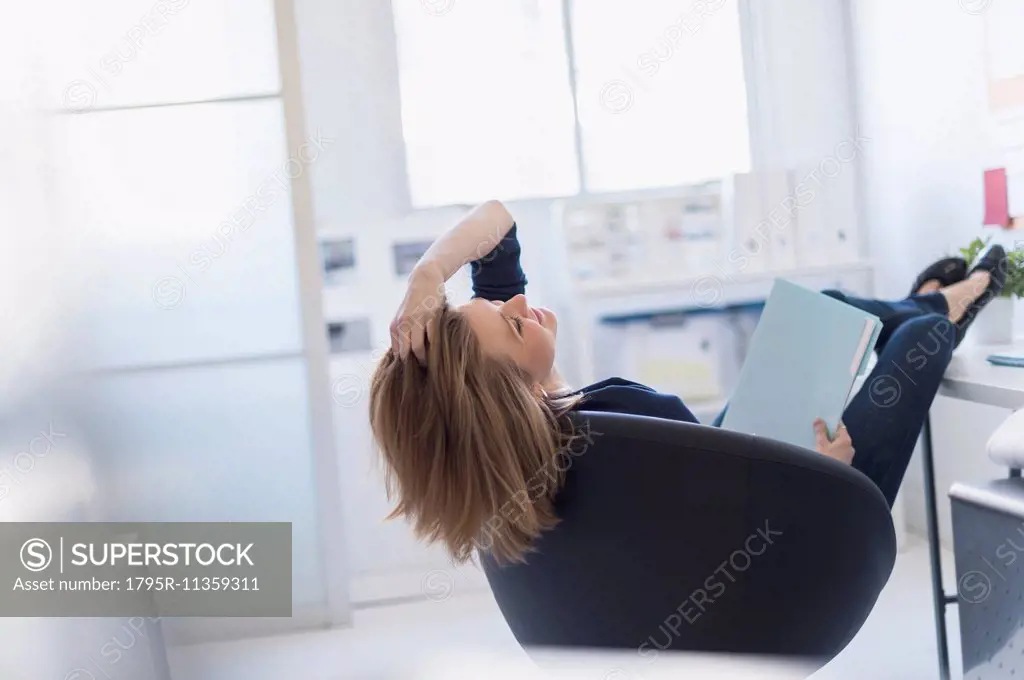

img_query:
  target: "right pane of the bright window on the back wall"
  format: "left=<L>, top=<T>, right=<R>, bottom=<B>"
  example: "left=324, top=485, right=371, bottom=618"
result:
left=572, top=0, right=751, bottom=193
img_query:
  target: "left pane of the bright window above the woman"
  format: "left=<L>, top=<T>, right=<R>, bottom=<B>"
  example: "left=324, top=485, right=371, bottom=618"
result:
left=392, top=0, right=579, bottom=206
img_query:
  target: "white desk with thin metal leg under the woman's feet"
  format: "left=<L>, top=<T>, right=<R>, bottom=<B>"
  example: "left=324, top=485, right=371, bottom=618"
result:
left=922, top=339, right=1024, bottom=680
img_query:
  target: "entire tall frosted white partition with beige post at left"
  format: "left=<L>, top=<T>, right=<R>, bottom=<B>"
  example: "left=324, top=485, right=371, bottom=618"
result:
left=37, top=0, right=350, bottom=642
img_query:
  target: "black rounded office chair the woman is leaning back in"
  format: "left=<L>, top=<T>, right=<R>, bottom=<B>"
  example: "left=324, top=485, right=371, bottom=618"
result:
left=480, top=413, right=896, bottom=663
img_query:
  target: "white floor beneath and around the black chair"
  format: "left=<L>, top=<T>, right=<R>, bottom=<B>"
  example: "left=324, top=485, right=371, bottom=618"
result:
left=170, top=539, right=961, bottom=680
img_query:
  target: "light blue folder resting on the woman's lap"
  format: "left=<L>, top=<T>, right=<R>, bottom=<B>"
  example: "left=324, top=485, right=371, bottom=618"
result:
left=722, top=279, right=882, bottom=450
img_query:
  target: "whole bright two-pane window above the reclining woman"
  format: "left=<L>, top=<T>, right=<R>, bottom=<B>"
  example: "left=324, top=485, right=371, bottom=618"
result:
left=392, top=0, right=750, bottom=207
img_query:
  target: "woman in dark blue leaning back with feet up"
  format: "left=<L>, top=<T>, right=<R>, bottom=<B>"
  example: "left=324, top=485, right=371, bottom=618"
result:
left=370, top=201, right=1007, bottom=561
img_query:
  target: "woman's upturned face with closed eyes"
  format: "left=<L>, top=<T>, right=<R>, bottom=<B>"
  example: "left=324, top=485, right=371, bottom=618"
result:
left=459, top=295, right=558, bottom=384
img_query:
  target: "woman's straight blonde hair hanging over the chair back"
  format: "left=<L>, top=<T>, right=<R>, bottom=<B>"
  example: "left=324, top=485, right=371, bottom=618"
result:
left=370, top=303, right=583, bottom=562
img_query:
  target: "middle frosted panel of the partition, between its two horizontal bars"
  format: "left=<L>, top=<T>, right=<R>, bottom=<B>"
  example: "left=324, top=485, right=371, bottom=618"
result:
left=53, top=100, right=301, bottom=368
